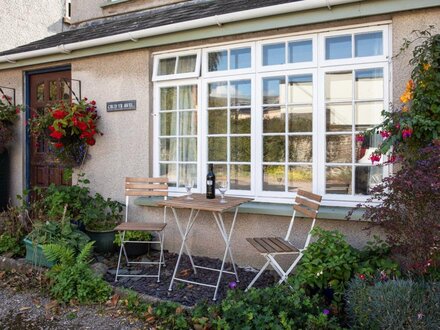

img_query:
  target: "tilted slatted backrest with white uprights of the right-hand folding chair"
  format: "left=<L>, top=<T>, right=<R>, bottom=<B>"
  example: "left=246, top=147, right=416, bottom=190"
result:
left=284, top=190, right=322, bottom=249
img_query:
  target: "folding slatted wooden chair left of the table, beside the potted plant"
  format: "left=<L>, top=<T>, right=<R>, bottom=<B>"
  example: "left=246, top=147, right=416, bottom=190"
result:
left=115, top=178, right=168, bottom=282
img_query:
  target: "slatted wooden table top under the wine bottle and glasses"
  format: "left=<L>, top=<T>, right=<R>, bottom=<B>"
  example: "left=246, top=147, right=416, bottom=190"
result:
left=157, top=194, right=253, bottom=212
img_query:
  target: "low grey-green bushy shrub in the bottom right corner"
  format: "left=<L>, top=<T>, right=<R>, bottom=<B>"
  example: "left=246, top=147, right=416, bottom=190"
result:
left=345, top=279, right=440, bottom=329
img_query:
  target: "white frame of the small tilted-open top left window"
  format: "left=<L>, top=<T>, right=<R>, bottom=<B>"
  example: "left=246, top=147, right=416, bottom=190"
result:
left=152, top=49, right=201, bottom=82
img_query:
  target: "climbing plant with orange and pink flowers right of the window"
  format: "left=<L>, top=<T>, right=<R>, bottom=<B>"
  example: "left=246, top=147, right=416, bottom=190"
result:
left=366, top=30, right=440, bottom=159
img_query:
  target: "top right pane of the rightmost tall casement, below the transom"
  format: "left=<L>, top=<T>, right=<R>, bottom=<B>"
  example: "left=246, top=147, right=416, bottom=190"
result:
left=355, top=68, right=383, bottom=100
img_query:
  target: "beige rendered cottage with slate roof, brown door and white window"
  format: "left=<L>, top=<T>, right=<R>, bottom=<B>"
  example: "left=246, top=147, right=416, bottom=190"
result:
left=0, top=0, right=440, bottom=265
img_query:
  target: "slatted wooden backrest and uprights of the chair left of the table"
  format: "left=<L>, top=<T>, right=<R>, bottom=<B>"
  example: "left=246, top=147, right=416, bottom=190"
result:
left=125, top=178, right=168, bottom=222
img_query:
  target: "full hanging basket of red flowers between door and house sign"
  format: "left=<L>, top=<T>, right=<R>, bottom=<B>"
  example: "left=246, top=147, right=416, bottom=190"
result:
left=30, top=98, right=102, bottom=167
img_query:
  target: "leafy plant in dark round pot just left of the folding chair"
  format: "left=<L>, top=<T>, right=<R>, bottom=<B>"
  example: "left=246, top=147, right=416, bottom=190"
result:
left=81, top=193, right=124, bottom=253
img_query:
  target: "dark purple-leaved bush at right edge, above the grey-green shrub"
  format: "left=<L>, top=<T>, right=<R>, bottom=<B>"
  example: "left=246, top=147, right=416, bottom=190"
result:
left=358, top=146, right=440, bottom=275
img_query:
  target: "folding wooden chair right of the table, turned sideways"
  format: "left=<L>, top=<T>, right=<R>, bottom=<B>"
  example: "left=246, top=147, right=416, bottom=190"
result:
left=246, top=190, right=322, bottom=291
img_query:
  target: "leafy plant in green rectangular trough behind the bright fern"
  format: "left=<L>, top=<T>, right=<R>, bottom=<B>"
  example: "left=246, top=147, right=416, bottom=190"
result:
left=23, top=219, right=90, bottom=267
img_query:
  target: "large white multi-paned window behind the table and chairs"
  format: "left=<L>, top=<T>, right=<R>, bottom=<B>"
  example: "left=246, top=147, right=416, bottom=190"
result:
left=153, top=25, right=389, bottom=204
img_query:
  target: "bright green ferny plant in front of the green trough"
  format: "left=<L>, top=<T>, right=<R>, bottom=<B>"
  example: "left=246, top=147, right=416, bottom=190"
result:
left=43, top=242, right=112, bottom=304
